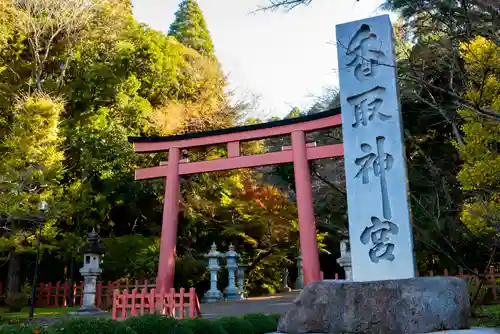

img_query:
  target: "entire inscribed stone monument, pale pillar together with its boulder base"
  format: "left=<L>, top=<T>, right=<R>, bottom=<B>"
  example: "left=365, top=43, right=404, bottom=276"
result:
left=278, top=15, right=470, bottom=334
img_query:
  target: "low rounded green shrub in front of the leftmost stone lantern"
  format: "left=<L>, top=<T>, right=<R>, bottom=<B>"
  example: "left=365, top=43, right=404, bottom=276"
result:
left=47, top=317, right=138, bottom=334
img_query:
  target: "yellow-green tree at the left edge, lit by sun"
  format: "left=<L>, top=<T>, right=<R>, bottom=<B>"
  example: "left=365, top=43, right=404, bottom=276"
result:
left=0, top=93, right=64, bottom=291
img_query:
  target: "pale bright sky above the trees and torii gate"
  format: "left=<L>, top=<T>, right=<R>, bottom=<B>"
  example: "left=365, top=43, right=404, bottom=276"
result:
left=132, top=0, right=383, bottom=118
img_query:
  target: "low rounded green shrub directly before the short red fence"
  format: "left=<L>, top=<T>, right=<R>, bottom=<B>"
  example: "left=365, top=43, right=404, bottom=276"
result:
left=124, top=315, right=192, bottom=334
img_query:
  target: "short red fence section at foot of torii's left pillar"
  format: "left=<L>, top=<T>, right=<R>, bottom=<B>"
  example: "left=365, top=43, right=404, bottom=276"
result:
left=112, top=288, right=201, bottom=320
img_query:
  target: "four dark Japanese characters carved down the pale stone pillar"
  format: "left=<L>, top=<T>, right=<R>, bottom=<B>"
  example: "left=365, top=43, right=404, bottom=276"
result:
left=345, top=24, right=399, bottom=263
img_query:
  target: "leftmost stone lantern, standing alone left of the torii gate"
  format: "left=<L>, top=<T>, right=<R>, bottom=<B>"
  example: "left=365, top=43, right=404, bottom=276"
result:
left=70, top=229, right=104, bottom=315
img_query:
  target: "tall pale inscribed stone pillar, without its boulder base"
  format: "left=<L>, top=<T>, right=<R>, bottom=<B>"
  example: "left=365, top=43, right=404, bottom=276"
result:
left=336, top=15, right=415, bottom=281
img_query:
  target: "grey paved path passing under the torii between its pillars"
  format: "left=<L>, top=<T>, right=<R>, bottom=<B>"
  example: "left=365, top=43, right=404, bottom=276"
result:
left=201, top=291, right=299, bottom=319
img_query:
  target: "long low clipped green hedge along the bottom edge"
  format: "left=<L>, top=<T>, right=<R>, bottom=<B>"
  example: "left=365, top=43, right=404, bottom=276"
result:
left=0, top=313, right=279, bottom=334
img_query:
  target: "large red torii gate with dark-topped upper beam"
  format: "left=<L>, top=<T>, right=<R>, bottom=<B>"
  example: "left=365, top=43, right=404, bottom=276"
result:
left=129, top=108, right=344, bottom=289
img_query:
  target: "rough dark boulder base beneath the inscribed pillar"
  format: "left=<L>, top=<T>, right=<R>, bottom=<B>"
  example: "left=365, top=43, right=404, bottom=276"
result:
left=278, top=277, right=470, bottom=334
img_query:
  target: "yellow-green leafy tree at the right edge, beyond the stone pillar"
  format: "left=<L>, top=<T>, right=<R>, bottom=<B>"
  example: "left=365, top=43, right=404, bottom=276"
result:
left=457, top=37, right=500, bottom=240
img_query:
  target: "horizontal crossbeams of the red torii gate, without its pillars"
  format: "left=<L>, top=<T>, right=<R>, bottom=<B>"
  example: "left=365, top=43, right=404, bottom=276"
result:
left=129, top=108, right=343, bottom=180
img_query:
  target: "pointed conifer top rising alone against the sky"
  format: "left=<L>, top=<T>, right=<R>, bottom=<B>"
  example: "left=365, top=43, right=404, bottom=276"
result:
left=168, top=0, right=214, bottom=56
